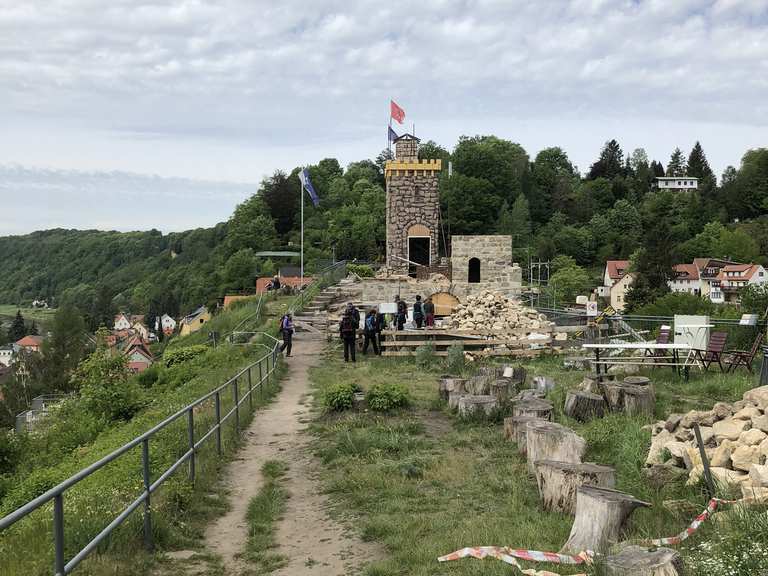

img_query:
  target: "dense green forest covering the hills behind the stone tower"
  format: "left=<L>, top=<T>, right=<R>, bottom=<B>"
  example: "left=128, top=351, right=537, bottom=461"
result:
left=0, top=136, right=768, bottom=322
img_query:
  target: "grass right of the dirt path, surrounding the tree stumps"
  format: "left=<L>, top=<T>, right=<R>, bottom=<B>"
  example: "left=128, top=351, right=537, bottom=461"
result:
left=311, top=354, right=768, bottom=576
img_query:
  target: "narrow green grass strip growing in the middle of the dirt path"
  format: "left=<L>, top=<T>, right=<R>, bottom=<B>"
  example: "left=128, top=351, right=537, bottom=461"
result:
left=245, top=460, right=288, bottom=574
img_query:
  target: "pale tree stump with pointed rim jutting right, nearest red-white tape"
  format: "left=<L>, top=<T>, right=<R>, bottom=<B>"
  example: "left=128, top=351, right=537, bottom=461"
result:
left=561, top=486, right=650, bottom=554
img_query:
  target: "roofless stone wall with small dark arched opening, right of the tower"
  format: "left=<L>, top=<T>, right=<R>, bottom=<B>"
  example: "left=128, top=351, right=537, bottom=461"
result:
left=451, top=235, right=523, bottom=300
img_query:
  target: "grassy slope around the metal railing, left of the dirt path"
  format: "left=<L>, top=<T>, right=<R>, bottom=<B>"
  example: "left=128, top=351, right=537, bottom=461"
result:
left=0, top=296, right=284, bottom=576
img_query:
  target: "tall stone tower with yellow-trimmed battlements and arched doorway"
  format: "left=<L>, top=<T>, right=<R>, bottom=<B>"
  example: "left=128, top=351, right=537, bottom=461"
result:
left=384, top=134, right=442, bottom=275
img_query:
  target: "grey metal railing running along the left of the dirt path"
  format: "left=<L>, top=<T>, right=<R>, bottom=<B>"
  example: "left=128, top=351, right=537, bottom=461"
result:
left=0, top=343, right=279, bottom=576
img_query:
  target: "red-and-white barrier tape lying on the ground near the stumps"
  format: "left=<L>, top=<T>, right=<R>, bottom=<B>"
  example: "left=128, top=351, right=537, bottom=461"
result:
left=437, top=498, right=741, bottom=576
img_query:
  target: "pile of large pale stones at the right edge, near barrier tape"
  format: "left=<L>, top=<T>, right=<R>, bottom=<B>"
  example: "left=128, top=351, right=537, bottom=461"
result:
left=646, top=386, right=768, bottom=500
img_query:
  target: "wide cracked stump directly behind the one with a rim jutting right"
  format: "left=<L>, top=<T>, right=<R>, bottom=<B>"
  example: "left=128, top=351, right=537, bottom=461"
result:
left=535, top=460, right=616, bottom=515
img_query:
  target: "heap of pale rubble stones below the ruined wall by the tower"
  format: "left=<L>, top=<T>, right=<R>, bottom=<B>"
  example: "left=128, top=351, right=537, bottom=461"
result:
left=450, top=291, right=554, bottom=340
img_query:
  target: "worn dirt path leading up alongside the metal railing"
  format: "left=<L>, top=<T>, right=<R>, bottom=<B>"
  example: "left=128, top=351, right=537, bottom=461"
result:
left=200, top=334, right=374, bottom=576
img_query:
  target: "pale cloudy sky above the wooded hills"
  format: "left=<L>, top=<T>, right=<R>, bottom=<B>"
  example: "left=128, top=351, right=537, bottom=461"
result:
left=0, top=0, right=768, bottom=234
